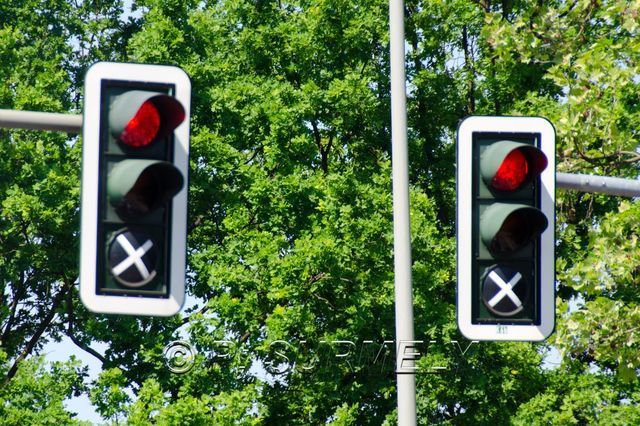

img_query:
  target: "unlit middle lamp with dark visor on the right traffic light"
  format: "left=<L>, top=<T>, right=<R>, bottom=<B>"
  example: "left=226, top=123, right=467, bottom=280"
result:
left=480, top=203, right=549, bottom=256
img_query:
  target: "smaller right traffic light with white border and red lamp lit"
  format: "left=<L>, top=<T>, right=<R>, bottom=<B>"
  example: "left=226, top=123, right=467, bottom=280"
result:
left=457, top=116, right=555, bottom=341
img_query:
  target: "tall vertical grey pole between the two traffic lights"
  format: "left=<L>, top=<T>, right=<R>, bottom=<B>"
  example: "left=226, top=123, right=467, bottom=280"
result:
left=389, top=0, right=416, bottom=426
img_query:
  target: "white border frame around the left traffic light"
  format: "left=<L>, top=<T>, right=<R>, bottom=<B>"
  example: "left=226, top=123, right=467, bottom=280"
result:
left=80, top=62, right=191, bottom=316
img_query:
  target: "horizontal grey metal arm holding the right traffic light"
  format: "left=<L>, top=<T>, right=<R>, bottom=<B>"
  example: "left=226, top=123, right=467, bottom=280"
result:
left=556, top=173, right=640, bottom=197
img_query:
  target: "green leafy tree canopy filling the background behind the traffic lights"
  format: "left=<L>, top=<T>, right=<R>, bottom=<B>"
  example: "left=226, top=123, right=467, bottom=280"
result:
left=0, top=0, right=640, bottom=425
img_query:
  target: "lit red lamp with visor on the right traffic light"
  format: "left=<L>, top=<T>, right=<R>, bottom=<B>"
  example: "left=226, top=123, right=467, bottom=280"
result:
left=480, top=141, right=547, bottom=192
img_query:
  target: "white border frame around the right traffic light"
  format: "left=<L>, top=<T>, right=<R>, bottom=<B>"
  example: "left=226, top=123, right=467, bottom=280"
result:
left=456, top=116, right=555, bottom=341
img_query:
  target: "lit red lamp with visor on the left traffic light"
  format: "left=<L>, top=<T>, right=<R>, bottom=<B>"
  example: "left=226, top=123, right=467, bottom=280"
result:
left=109, top=90, right=185, bottom=148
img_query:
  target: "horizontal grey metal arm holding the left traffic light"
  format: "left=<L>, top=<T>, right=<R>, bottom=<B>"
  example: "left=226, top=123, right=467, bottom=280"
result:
left=0, top=109, right=82, bottom=133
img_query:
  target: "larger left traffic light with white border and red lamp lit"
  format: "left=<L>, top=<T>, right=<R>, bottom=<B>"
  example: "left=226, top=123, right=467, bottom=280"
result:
left=80, top=62, right=191, bottom=316
